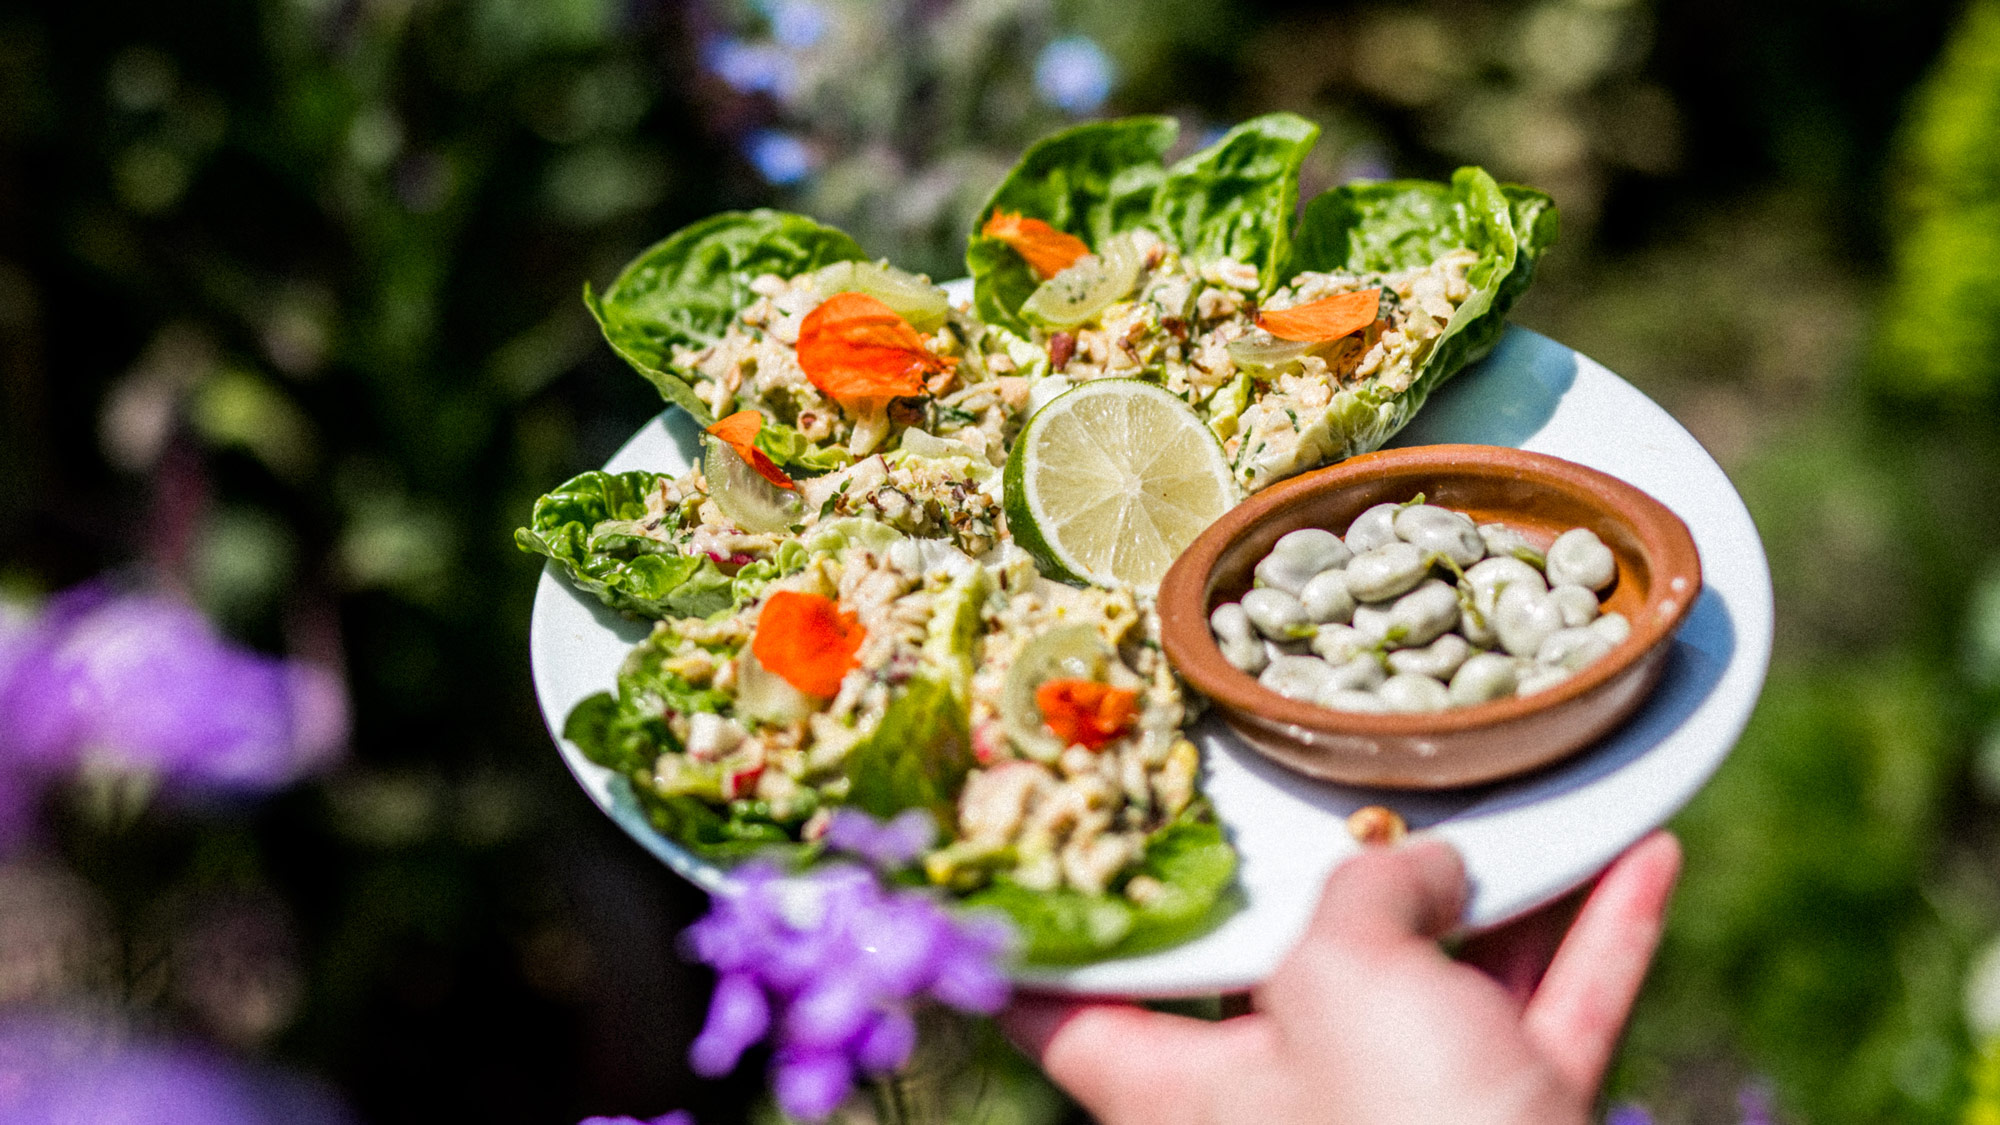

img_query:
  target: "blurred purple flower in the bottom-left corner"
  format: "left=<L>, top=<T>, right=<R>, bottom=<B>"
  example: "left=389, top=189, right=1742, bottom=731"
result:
left=0, top=1013, right=354, bottom=1125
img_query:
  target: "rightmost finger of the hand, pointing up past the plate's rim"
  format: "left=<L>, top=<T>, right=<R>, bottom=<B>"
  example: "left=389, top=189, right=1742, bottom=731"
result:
left=1522, top=833, right=1680, bottom=1093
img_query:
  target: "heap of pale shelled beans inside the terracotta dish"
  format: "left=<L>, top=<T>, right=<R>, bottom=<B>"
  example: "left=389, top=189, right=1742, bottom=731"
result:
left=1208, top=496, right=1632, bottom=711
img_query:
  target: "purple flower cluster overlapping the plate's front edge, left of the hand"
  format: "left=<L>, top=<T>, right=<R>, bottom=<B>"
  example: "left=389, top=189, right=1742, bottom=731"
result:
left=684, top=856, right=1012, bottom=1121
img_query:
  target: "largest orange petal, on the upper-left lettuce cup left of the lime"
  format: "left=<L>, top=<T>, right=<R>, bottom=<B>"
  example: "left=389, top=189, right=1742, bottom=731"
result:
left=798, top=292, right=958, bottom=402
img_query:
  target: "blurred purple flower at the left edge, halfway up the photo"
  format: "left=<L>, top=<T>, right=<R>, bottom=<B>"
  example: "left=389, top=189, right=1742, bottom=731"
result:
left=0, top=585, right=346, bottom=839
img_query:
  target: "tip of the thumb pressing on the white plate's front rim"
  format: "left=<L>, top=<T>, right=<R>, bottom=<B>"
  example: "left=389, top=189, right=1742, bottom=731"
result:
left=1306, top=837, right=1466, bottom=951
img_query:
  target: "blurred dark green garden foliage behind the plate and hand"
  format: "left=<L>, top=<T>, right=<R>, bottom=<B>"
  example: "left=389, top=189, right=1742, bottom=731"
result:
left=0, top=0, right=2000, bottom=1125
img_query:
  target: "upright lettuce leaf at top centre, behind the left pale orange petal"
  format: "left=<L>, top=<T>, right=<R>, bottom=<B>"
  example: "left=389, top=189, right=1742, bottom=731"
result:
left=966, top=116, right=1180, bottom=336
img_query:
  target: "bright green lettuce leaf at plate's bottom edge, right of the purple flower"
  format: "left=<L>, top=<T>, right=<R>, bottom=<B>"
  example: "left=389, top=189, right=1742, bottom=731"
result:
left=964, top=805, right=1236, bottom=965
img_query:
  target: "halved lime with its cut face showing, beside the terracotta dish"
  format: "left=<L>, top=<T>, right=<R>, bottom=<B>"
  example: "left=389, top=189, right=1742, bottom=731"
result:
left=1006, top=378, right=1238, bottom=589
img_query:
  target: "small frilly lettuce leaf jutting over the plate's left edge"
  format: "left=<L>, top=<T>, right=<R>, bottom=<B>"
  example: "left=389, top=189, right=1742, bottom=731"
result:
left=514, top=470, right=736, bottom=619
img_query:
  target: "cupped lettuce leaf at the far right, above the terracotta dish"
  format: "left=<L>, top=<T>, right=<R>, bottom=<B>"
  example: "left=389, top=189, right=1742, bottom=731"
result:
left=1282, top=168, right=1556, bottom=460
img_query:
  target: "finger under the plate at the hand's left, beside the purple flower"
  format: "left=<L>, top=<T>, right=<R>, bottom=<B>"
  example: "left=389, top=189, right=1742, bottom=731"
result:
left=998, top=997, right=1262, bottom=1125
